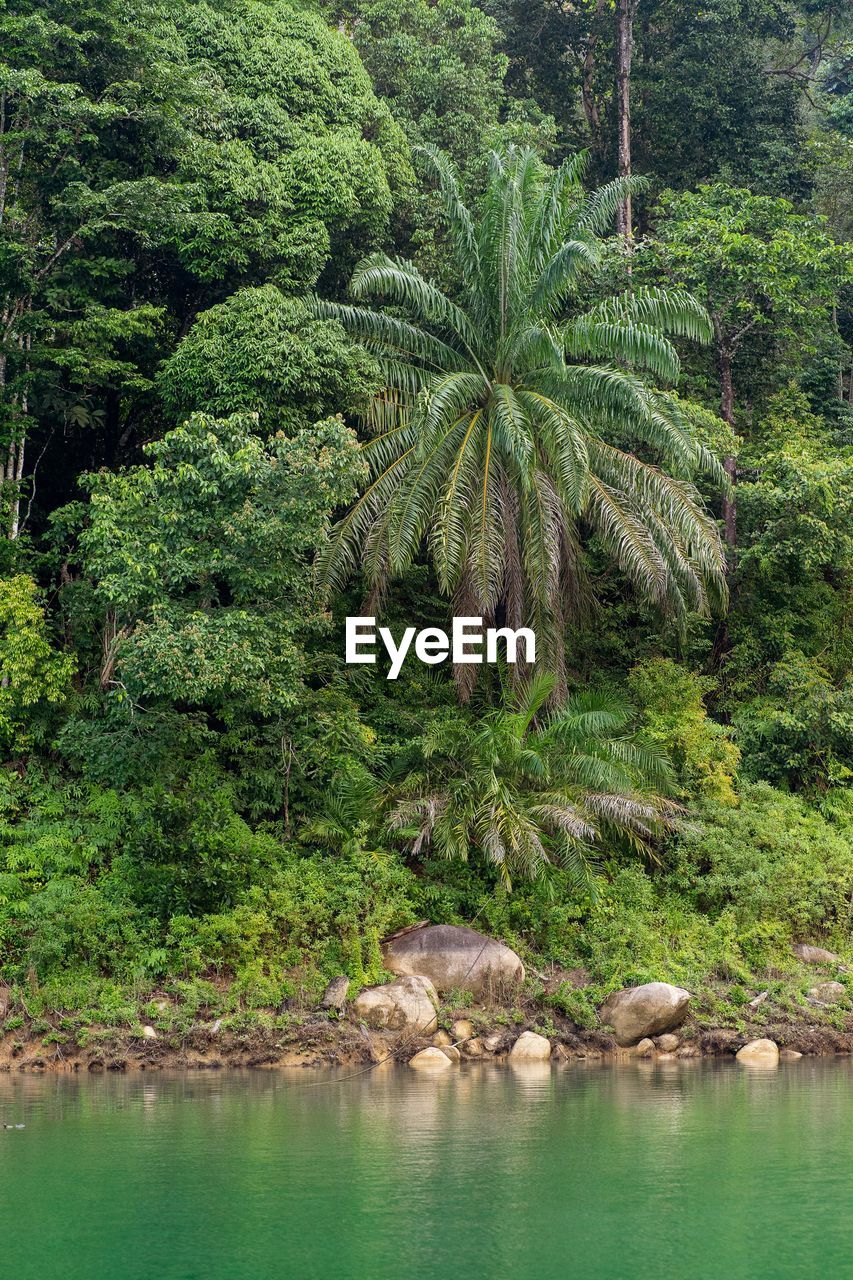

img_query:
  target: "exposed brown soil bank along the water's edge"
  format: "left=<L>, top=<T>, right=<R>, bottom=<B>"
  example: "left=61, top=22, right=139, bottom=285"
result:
left=0, top=1011, right=853, bottom=1073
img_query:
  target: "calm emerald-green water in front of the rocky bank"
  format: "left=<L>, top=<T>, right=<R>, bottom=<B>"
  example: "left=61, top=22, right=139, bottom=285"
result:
left=0, top=1060, right=853, bottom=1280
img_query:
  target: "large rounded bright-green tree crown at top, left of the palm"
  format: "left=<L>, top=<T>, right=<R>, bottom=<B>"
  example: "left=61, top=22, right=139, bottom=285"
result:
left=175, top=0, right=411, bottom=293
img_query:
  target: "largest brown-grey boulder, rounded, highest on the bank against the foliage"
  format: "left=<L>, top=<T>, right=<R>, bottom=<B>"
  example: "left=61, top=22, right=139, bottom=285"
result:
left=382, top=924, right=524, bottom=996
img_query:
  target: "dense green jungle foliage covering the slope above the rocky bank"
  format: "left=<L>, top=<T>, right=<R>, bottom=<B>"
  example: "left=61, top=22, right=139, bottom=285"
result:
left=0, top=0, right=853, bottom=1024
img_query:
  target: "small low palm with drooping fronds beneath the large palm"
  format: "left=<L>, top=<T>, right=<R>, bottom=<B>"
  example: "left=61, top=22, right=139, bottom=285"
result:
left=389, top=675, right=680, bottom=888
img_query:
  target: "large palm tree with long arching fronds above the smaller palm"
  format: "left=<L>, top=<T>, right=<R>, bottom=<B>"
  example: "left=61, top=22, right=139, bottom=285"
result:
left=315, top=147, right=725, bottom=696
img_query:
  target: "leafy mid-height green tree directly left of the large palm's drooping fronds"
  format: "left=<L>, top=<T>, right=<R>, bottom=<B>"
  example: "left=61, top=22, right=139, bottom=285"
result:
left=81, top=415, right=362, bottom=721
